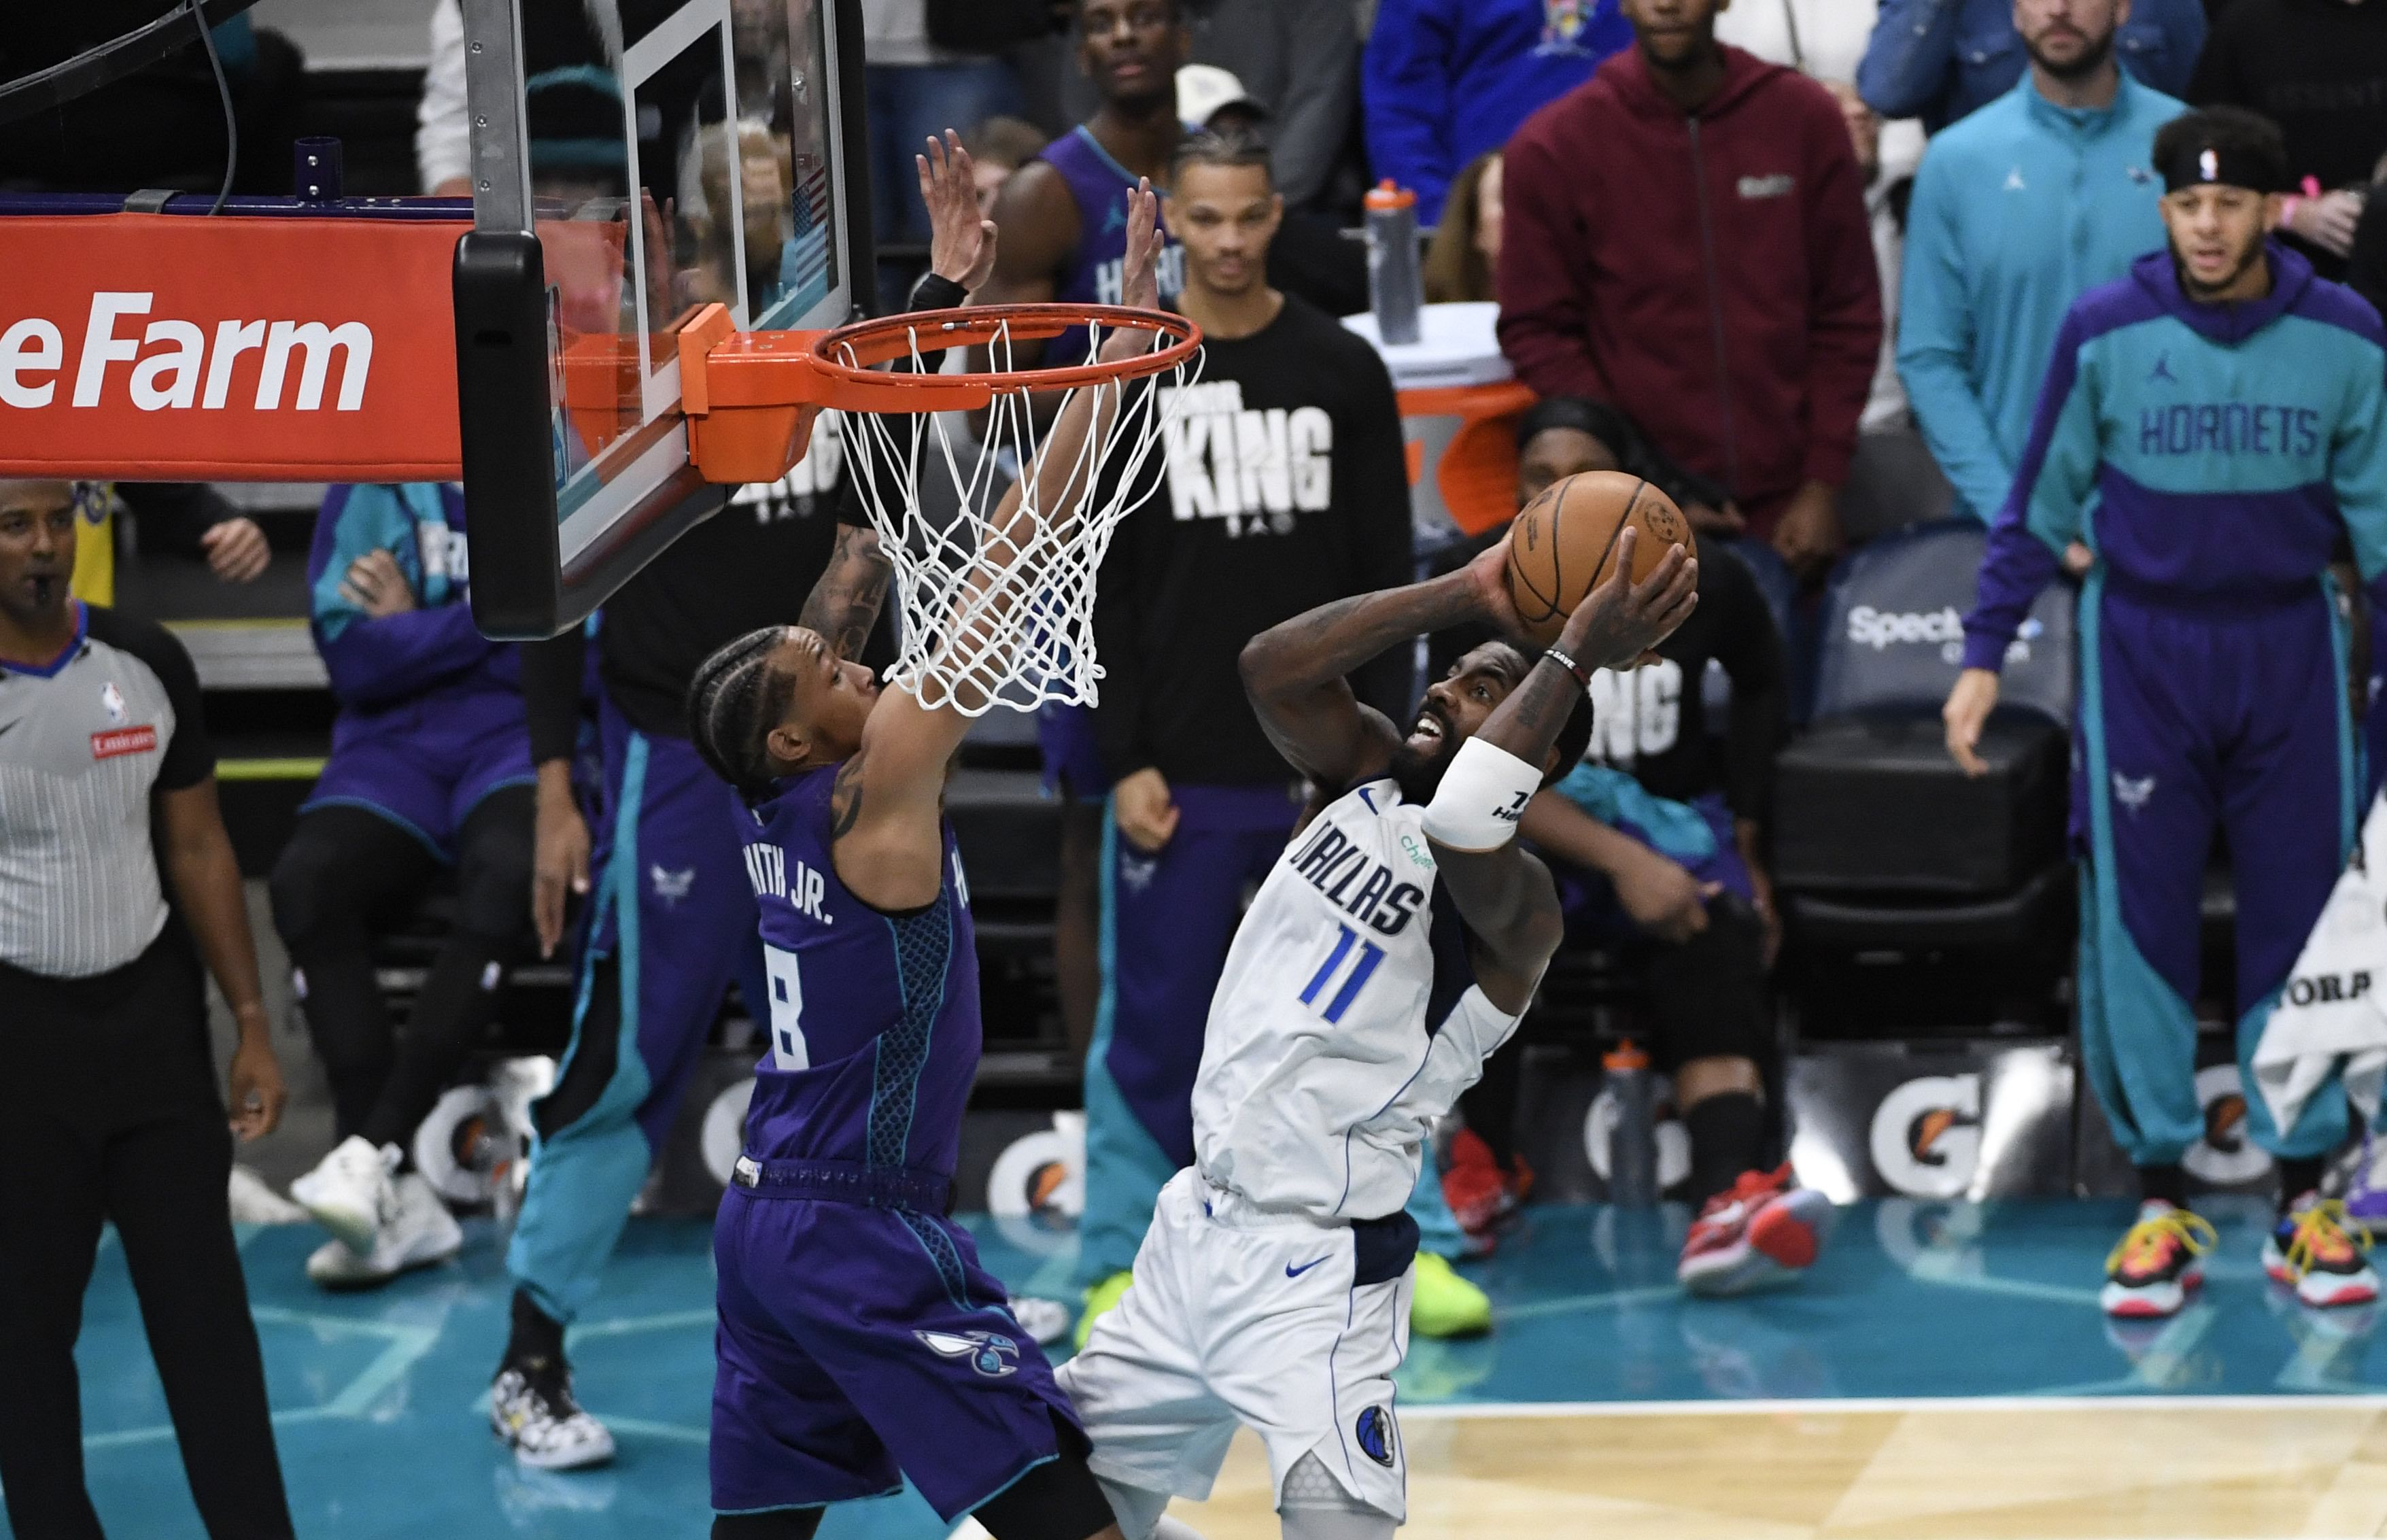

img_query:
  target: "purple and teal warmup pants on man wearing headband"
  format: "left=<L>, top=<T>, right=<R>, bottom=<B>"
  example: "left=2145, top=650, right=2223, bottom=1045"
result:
left=2072, top=570, right=2363, bottom=1165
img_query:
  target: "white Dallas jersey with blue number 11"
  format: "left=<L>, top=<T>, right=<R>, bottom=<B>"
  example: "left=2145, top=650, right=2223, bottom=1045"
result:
left=1194, top=778, right=1515, bottom=1220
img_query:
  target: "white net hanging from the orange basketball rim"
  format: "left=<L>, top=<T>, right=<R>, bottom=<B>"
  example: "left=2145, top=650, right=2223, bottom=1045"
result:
left=840, top=325, right=1201, bottom=716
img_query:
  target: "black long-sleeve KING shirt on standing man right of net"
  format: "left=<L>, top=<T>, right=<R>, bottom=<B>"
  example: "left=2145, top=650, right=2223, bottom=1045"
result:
left=1093, top=296, right=1413, bottom=785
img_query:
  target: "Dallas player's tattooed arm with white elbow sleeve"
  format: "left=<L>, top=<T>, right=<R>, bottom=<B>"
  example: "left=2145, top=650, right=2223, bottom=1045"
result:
left=1425, top=528, right=1700, bottom=1010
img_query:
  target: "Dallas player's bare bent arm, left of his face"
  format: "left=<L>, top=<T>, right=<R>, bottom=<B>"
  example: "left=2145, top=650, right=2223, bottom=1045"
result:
left=1241, top=540, right=1518, bottom=793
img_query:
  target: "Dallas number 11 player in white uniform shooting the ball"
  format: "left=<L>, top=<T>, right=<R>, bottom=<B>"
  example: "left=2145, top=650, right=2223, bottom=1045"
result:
left=1060, top=530, right=1697, bottom=1540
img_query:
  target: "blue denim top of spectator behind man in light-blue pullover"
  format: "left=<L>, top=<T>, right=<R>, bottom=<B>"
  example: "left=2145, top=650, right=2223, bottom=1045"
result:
left=1857, top=0, right=2205, bottom=134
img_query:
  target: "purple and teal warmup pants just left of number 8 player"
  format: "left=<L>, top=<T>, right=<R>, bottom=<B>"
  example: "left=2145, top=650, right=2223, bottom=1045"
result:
left=506, top=704, right=766, bottom=1320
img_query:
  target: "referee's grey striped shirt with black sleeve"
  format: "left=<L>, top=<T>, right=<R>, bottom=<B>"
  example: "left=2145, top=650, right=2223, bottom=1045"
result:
left=0, top=604, right=215, bottom=979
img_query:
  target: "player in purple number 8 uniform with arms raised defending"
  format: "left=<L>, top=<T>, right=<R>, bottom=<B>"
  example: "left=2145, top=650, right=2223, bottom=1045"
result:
left=687, top=160, right=1160, bottom=1540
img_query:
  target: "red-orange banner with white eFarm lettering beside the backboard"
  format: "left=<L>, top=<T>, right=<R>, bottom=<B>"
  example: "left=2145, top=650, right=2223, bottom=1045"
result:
left=0, top=215, right=466, bottom=482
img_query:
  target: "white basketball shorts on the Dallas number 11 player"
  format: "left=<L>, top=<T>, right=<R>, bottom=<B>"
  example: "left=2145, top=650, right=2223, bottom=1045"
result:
left=1055, top=1170, right=1413, bottom=1521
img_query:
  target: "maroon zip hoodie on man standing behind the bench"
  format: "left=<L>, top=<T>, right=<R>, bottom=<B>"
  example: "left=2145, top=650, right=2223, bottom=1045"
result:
left=1499, top=48, right=1881, bottom=535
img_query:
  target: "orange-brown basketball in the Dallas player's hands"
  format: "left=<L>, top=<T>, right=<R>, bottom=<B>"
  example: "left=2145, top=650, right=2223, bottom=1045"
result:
left=1509, top=470, right=1700, bottom=647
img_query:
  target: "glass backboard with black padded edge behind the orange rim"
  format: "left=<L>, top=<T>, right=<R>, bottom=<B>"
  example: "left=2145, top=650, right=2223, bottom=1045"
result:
left=456, top=0, right=872, bottom=638
